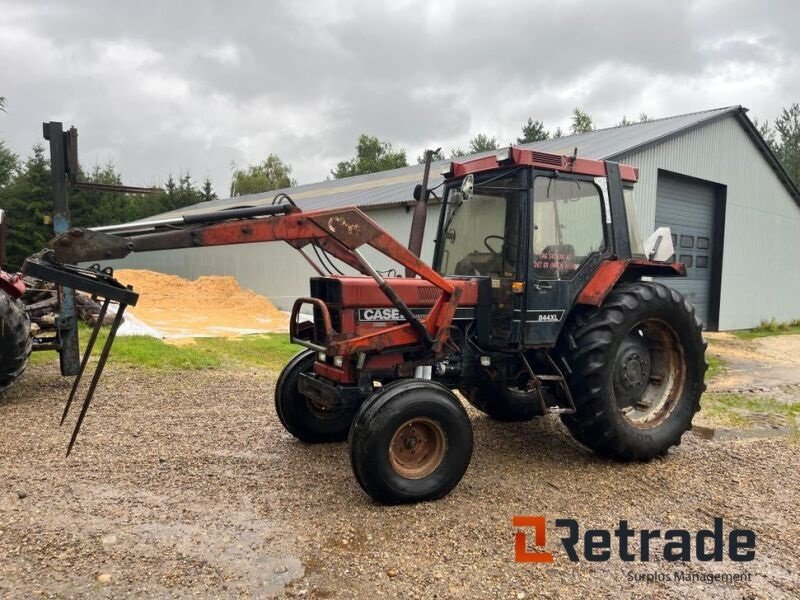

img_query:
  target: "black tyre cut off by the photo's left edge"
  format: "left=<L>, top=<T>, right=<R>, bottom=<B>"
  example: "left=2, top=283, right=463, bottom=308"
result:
left=0, top=291, right=33, bottom=392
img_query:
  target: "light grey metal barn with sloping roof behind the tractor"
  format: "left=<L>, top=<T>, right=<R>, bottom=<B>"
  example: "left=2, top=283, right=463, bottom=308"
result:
left=109, top=106, right=800, bottom=330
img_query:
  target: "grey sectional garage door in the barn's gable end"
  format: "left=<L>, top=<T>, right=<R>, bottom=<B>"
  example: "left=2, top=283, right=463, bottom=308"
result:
left=656, top=173, right=714, bottom=323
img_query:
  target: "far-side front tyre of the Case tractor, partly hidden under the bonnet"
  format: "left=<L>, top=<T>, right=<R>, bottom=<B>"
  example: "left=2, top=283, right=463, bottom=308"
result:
left=275, top=350, right=357, bottom=444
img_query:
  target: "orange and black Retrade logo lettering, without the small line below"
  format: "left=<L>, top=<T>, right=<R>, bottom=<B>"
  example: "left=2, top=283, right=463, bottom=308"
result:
left=511, top=516, right=756, bottom=563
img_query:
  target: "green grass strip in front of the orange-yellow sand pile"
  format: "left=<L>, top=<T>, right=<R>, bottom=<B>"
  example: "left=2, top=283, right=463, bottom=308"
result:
left=31, top=325, right=301, bottom=371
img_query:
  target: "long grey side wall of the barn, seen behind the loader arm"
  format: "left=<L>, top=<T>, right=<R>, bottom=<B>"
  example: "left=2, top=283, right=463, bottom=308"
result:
left=103, top=205, right=439, bottom=310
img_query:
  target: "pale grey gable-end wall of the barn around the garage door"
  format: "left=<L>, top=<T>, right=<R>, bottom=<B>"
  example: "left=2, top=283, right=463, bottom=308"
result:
left=619, top=117, right=800, bottom=330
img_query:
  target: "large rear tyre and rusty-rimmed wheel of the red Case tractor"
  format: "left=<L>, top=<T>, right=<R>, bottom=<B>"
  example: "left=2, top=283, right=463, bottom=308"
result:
left=558, top=282, right=708, bottom=460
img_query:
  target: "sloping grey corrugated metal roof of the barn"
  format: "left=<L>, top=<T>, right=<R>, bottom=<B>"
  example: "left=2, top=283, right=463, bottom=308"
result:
left=141, top=106, right=780, bottom=220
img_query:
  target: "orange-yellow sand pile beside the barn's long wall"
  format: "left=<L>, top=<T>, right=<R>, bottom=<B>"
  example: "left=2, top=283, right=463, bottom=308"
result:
left=115, top=269, right=289, bottom=338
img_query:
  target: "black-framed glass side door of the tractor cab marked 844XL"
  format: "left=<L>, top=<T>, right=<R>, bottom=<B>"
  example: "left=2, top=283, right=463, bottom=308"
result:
left=521, top=173, right=610, bottom=347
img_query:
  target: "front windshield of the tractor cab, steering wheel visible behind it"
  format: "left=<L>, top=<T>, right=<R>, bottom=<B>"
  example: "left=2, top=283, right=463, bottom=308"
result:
left=438, top=169, right=527, bottom=277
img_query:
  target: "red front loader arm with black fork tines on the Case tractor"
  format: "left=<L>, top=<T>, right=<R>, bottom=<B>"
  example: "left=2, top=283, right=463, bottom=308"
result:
left=23, top=201, right=460, bottom=455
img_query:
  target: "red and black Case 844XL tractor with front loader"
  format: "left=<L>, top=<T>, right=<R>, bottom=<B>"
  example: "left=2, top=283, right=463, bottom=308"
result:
left=20, top=148, right=706, bottom=503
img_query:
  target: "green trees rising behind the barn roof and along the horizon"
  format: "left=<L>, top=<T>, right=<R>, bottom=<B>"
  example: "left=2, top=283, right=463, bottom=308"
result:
left=0, top=97, right=800, bottom=267
